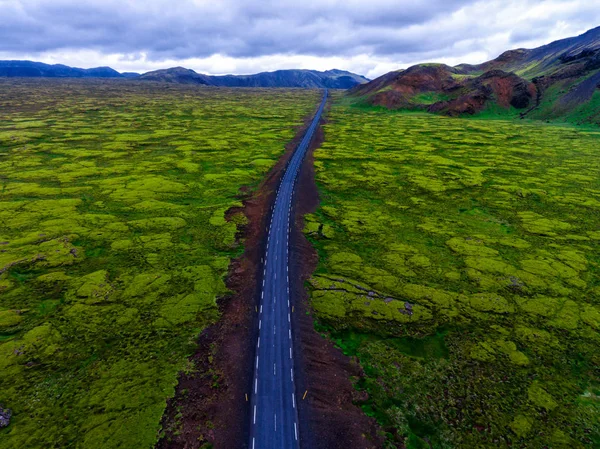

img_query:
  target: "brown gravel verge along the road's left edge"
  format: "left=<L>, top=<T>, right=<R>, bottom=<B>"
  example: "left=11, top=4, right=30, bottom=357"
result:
left=156, top=102, right=322, bottom=449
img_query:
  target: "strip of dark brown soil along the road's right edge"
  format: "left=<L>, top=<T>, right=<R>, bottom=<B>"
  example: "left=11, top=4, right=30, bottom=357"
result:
left=290, top=106, right=383, bottom=449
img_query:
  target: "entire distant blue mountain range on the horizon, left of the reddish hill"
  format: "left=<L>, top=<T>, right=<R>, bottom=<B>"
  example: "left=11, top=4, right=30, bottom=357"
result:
left=0, top=61, right=369, bottom=89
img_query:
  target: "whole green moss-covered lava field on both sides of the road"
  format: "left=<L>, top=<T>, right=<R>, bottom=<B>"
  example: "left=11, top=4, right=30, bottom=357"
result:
left=0, top=80, right=600, bottom=449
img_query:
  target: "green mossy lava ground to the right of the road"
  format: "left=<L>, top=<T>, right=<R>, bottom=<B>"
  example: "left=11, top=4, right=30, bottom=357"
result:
left=305, top=101, right=600, bottom=449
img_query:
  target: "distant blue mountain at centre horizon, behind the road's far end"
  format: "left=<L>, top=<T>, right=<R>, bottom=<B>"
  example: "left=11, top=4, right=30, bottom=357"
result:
left=138, top=67, right=369, bottom=89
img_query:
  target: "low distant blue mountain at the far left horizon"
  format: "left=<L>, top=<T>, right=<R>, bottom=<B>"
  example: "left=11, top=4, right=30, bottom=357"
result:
left=0, top=61, right=123, bottom=78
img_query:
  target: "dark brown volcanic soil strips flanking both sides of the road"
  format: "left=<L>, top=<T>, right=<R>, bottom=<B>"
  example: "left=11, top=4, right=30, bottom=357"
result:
left=156, top=95, right=380, bottom=449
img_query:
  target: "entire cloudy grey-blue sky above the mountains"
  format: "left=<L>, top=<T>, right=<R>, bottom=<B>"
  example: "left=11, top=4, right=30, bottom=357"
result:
left=0, top=0, right=600, bottom=78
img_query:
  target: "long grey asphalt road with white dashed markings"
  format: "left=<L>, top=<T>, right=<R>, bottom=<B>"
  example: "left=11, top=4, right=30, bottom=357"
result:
left=250, top=89, right=327, bottom=449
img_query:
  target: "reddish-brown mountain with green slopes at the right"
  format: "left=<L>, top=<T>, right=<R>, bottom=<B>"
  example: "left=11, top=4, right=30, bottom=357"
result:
left=349, top=27, right=600, bottom=124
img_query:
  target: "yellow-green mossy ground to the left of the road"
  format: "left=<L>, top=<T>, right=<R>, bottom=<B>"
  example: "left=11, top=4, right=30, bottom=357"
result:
left=0, top=80, right=320, bottom=449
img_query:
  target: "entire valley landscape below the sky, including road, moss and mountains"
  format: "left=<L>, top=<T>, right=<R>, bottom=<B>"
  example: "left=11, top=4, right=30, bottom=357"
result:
left=0, top=28, right=600, bottom=449
